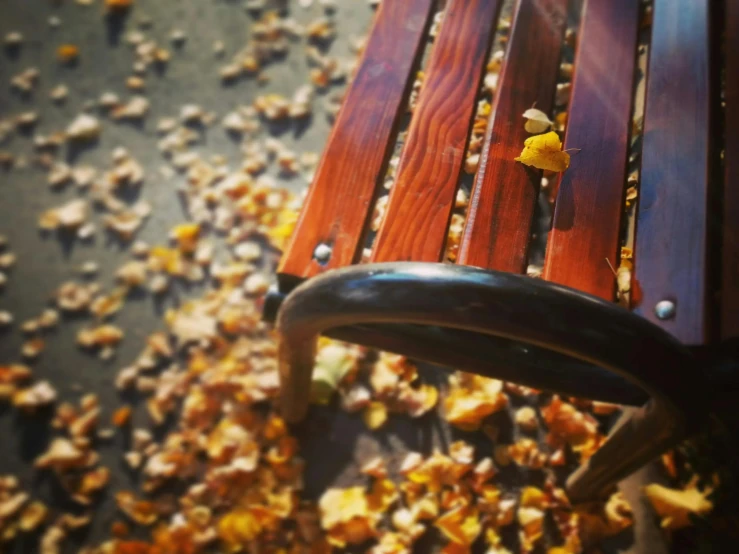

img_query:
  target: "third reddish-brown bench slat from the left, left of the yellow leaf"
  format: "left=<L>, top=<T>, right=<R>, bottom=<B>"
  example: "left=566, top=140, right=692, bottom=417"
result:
left=458, top=0, right=567, bottom=273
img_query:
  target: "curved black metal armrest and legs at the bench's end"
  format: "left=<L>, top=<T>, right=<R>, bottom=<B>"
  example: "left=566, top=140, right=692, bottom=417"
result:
left=277, top=263, right=708, bottom=502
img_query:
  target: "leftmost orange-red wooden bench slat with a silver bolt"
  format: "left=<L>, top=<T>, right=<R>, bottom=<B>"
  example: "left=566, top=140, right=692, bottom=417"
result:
left=278, top=0, right=435, bottom=282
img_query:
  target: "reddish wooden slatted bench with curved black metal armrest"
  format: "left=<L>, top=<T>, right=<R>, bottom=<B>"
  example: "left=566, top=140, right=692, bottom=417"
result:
left=266, top=0, right=739, bottom=502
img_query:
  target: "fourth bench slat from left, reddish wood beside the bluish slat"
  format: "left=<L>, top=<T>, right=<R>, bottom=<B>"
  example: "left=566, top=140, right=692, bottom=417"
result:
left=543, top=0, right=640, bottom=300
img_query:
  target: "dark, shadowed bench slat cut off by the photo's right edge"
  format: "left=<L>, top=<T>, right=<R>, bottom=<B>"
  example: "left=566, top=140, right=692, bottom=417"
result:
left=720, top=0, right=739, bottom=339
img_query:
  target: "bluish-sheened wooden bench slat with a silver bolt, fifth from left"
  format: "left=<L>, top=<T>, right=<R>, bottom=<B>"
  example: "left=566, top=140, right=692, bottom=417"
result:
left=635, top=0, right=711, bottom=344
